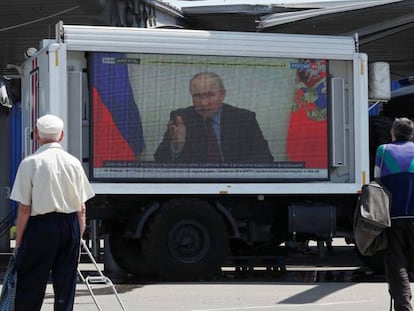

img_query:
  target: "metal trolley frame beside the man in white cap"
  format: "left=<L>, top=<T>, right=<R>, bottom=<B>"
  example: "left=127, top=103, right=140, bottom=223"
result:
left=78, top=239, right=126, bottom=311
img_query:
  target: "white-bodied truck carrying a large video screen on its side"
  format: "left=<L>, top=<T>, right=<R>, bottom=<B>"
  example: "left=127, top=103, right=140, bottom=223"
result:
left=17, top=22, right=390, bottom=280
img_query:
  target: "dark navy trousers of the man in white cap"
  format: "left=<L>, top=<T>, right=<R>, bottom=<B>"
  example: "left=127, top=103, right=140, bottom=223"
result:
left=15, top=213, right=80, bottom=311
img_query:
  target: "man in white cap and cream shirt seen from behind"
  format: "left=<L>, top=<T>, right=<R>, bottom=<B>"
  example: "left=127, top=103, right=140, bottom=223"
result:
left=10, top=115, right=94, bottom=311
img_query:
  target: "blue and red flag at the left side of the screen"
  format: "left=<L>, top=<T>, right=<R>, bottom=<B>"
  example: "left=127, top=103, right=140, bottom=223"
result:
left=88, top=53, right=145, bottom=168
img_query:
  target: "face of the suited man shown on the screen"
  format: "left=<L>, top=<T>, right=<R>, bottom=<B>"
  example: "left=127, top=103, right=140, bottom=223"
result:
left=191, top=76, right=226, bottom=119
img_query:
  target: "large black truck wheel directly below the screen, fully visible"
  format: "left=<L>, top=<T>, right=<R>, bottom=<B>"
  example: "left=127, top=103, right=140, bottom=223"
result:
left=142, top=199, right=228, bottom=280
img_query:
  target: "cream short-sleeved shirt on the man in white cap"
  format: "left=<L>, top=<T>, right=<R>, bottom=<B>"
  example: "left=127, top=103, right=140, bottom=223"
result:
left=10, top=143, right=95, bottom=216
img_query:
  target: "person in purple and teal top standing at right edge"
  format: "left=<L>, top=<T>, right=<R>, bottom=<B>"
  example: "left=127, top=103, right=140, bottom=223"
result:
left=374, top=118, right=414, bottom=311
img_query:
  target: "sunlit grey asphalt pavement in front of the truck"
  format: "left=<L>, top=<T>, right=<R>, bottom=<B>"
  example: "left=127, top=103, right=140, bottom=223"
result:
left=0, top=241, right=389, bottom=311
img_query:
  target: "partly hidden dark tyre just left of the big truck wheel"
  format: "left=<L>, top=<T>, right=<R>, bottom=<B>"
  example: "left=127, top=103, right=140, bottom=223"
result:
left=109, top=232, right=155, bottom=277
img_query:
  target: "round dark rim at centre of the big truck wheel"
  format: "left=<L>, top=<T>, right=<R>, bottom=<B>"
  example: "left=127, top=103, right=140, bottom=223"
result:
left=168, top=220, right=210, bottom=263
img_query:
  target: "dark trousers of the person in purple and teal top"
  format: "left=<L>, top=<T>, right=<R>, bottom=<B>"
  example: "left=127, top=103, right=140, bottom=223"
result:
left=384, top=218, right=414, bottom=311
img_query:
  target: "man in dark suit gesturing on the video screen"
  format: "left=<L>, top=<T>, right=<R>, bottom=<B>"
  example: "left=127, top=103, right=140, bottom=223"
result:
left=154, top=72, right=273, bottom=163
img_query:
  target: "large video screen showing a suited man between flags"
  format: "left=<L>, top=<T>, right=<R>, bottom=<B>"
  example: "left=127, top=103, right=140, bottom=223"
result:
left=88, top=52, right=328, bottom=182
